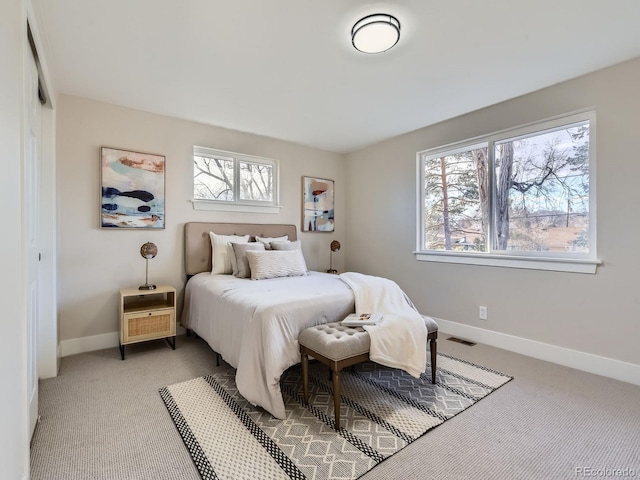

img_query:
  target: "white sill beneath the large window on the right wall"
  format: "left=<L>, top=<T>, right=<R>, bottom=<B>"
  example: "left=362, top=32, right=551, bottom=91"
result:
left=414, top=252, right=602, bottom=274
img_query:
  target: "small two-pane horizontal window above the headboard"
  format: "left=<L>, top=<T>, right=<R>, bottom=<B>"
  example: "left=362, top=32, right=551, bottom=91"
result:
left=193, top=147, right=278, bottom=211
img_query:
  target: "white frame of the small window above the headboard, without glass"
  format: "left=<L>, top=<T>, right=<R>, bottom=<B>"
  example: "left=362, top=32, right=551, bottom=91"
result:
left=191, top=145, right=281, bottom=213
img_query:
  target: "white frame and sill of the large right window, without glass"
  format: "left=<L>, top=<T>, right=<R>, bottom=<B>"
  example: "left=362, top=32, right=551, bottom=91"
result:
left=414, top=109, right=601, bottom=274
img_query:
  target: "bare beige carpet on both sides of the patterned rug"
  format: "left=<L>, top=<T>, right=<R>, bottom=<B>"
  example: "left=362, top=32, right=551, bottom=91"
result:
left=31, top=337, right=640, bottom=480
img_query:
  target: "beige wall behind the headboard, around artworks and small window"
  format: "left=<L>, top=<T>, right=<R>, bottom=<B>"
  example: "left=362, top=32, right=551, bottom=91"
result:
left=57, top=95, right=346, bottom=341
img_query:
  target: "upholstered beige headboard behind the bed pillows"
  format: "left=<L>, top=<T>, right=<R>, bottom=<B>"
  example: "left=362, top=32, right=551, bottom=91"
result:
left=184, top=222, right=298, bottom=275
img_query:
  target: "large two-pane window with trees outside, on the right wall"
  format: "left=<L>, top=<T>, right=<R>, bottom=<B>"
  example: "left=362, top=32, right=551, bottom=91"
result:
left=417, top=112, right=598, bottom=272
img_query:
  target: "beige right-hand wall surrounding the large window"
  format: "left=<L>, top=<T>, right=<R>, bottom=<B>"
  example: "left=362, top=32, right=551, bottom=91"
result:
left=345, top=59, right=640, bottom=365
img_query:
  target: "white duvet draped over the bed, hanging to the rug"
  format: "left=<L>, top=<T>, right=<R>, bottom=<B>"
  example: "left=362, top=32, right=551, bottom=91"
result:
left=182, top=272, right=354, bottom=418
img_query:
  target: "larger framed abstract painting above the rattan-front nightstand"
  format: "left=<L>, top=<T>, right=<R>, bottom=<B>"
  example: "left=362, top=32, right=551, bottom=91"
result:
left=100, top=147, right=165, bottom=229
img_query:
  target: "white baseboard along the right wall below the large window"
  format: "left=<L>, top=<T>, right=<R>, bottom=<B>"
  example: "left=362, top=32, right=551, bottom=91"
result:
left=434, top=317, right=640, bottom=385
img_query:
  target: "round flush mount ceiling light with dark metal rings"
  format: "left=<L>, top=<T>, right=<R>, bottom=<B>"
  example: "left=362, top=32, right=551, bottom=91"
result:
left=351, top=13, right=400, bottom=53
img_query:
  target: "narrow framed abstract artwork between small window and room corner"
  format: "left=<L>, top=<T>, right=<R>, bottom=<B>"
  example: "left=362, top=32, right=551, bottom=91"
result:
left=302, top=177, right=334, bottom=232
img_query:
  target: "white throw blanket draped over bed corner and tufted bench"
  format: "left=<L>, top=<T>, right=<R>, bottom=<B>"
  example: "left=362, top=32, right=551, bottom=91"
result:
left=340, top=272, right=427, bottom=377
